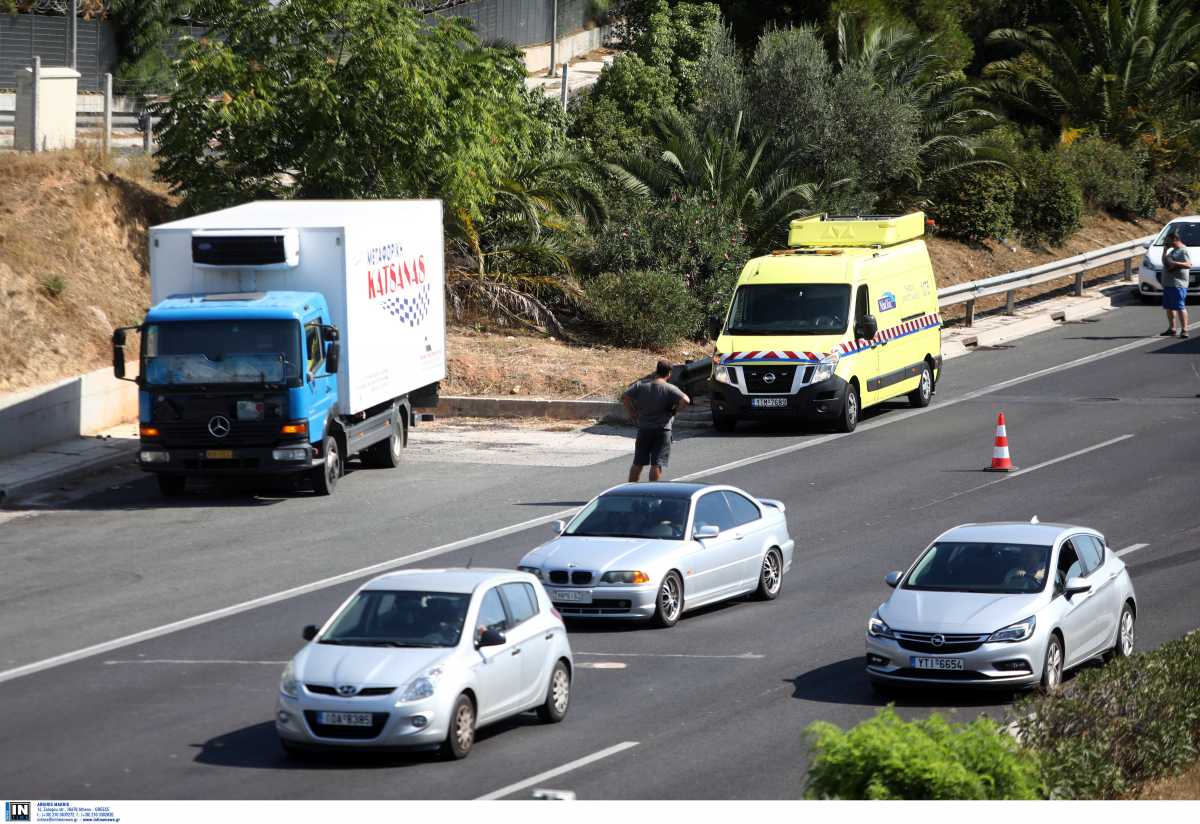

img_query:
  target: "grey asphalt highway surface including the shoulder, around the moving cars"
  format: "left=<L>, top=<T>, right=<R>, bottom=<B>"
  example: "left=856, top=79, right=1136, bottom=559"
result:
left=0, top=301, right=1200, bottom=799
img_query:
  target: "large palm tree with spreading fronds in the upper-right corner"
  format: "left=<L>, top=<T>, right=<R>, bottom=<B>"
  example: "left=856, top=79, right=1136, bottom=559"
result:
left=984, top=0, right=1200, bottom=145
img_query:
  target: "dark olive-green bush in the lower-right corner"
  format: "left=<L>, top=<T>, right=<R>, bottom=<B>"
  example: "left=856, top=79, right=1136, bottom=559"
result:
left=1013, top=632, right=1200, bottom=799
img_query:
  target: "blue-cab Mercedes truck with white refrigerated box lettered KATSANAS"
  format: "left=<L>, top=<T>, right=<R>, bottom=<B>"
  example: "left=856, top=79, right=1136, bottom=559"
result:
left=113, top=200, right=445, bottom=495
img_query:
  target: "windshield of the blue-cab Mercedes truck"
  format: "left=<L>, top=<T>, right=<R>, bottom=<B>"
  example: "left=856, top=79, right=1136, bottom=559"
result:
left=142, top=320, right=300, bottom=386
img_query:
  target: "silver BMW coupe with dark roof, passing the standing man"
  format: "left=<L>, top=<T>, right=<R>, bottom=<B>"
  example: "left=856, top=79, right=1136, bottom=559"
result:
left=518, top=483, right=794, bottom=627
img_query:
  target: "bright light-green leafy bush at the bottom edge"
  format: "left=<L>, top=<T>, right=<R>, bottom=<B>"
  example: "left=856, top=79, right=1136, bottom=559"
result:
left=806, top=706, right=1042, bottom=800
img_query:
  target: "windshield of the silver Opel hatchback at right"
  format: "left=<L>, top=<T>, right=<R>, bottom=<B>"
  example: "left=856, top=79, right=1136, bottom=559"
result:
left=902, top=541, right=1050, bottom=595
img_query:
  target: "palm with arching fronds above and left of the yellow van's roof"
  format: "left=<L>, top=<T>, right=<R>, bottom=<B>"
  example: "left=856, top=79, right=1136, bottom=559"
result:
left=608, top=112, right=825, bottom=249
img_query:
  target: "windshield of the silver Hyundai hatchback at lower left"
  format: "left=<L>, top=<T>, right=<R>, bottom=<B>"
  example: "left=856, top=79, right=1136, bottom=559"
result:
left=317, top=589, right=470, bottom=646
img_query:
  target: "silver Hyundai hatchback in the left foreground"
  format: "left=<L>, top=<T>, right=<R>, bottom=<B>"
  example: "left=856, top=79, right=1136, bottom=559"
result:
left=275, top=569, right=575, bottom=758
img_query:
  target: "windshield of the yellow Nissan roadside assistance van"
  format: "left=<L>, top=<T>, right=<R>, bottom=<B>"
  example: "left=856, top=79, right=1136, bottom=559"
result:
left=725, top=283, right=850, bottom=335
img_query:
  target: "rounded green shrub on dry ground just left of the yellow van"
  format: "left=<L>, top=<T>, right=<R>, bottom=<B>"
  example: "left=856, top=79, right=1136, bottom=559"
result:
left=584, top=271, right=704, bottom=349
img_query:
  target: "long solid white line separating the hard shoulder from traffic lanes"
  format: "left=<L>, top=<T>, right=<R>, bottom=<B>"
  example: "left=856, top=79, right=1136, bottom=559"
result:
left=0, top=331, right=1171, bottom=684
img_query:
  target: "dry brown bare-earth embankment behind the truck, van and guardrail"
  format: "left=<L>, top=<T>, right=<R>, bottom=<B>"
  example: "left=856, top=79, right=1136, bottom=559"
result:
left=0, top=152, right=1180, bottom=399
